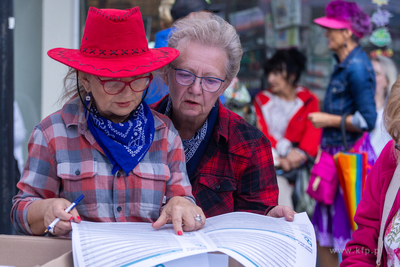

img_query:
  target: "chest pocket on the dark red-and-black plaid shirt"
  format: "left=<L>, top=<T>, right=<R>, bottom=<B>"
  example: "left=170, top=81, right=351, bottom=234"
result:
left=196, top=175, right=237, bottom=216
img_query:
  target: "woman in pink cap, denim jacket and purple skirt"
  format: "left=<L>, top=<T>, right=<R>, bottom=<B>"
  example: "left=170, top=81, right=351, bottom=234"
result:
left=308, top=0, right=377, bottom=267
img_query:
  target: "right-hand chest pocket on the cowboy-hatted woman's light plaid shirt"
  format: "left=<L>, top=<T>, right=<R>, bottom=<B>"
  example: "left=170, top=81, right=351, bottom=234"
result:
left=129, top=163, right=171, bottom=218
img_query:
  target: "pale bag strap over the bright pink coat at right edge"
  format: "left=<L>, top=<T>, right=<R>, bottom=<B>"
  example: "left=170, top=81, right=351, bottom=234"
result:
left=376, top=164, right=400, bottom=266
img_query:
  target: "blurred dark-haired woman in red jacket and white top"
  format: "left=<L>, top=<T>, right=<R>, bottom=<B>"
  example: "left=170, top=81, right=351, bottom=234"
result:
left=254, top=48, right=322, bottom=207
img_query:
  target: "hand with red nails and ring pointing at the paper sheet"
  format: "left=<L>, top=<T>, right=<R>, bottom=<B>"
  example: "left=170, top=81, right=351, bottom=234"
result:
left=153, top=196, right=206, bottom=235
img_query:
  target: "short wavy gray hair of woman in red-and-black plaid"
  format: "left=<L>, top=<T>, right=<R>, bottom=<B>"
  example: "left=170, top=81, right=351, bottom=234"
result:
left=168, top=12, right=243, bottom=80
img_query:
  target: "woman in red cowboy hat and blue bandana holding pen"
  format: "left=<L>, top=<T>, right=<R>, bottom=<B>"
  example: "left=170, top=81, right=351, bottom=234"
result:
left=11, top=7, right=205, bottom=238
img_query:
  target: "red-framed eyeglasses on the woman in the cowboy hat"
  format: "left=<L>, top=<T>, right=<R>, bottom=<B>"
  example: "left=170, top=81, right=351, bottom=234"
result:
left=95, top=73, right=153, bottom=95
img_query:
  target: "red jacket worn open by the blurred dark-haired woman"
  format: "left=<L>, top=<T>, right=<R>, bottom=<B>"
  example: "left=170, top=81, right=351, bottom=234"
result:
left=254, top=87, right=322, bottom=157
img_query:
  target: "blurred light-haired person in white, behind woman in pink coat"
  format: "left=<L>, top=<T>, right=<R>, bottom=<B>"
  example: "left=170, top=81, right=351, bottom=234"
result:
left=370, top=56, right=398, bottom=156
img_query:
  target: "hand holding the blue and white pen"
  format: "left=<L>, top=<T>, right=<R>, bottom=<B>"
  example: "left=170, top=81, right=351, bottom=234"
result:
left=28, top=198, right=81, bottom=236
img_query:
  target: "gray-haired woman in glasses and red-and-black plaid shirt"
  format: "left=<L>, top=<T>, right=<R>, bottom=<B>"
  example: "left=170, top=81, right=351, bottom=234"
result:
left=151, top=12, right=294, bottom=220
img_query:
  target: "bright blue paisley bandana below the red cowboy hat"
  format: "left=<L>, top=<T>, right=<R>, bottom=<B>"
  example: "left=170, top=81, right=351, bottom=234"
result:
left=86, top=101, right=155, bottom=174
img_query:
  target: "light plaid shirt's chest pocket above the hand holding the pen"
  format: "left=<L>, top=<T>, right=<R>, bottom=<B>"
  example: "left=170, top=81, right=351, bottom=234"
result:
left=57, top=161, right=99, bottom=213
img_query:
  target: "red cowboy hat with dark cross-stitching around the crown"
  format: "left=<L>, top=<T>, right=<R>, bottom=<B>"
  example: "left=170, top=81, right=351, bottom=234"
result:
left=47, top=7, right=179, bottom=78
